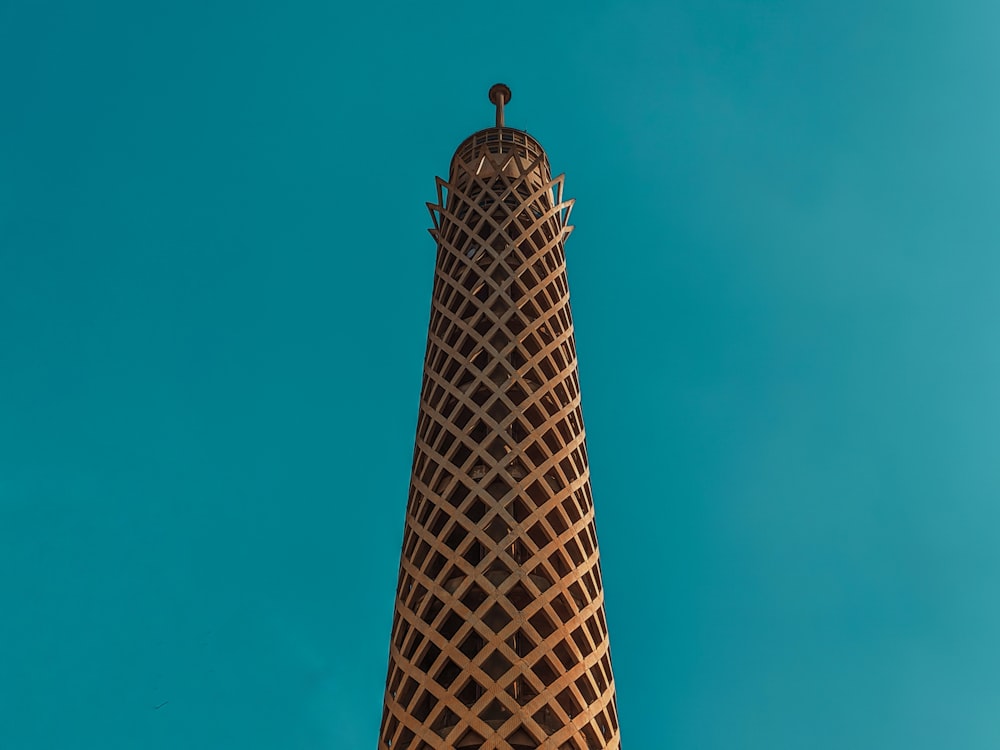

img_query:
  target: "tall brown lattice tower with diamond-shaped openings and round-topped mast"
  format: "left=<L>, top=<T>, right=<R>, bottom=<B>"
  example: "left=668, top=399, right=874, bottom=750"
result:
left=378, top=84, right=620, bottom=750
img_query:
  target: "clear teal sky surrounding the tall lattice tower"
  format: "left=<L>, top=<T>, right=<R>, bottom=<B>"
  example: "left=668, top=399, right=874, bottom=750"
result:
left=0, top=0, right=1000, bottom=750
